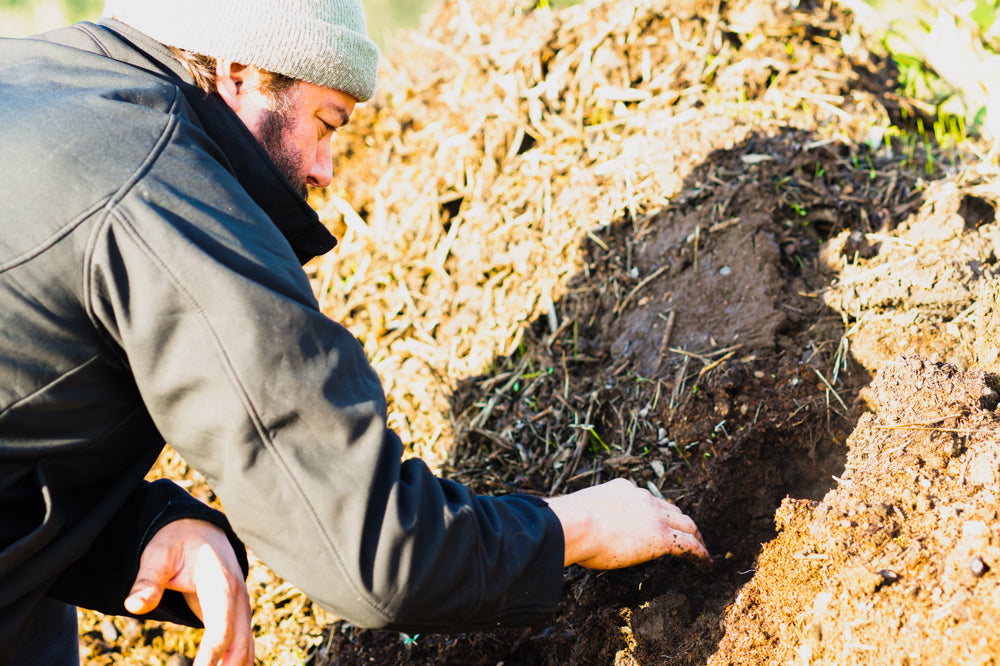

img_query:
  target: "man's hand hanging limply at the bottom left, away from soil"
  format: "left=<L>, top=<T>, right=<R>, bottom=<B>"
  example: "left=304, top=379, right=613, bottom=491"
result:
left=125, top=518, right=254, bottom=666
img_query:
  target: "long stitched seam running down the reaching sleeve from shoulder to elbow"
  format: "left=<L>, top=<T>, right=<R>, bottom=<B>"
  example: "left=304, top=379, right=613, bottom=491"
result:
left=96, top=162, right=394, bottom=621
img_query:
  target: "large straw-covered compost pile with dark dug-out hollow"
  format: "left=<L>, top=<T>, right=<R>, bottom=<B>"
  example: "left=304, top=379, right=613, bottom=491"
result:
left=83, top=0, right=1000, bottom=666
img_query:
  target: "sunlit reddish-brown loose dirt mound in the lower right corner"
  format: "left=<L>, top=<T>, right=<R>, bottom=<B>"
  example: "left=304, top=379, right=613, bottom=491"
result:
left=709, top=355, right=1000, bottom=664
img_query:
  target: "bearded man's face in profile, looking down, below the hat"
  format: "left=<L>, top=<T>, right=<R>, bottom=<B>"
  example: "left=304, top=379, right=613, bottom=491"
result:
left=237, top=76, right=356, bottom=196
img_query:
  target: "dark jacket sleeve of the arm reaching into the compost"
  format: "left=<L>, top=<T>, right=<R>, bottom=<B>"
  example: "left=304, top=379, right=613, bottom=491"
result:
left=89, top=120, right=564, bottom=632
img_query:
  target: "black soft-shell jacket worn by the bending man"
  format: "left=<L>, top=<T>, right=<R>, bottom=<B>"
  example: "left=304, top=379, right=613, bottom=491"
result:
left=0, top=21, right=563, bottom=663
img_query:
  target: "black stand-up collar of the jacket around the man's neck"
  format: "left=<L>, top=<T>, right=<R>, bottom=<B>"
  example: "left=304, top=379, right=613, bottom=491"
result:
left=87, top=18, right=337, bottom=264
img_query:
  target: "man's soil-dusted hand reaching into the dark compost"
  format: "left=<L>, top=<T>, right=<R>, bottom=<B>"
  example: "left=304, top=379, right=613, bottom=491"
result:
left=546, top=479, right=710, bottom=569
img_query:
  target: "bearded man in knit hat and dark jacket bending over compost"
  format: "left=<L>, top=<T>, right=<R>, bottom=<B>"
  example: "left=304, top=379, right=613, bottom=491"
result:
left=0, top=0, right=708, bottom=666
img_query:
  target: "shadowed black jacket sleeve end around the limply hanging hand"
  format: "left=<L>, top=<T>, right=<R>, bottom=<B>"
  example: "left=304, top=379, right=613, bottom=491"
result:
left=48, top=479, right=248, bottom=627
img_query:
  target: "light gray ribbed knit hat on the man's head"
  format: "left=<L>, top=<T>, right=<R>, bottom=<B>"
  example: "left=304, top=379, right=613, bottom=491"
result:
left=104, top=0, right=379, bottom=102
